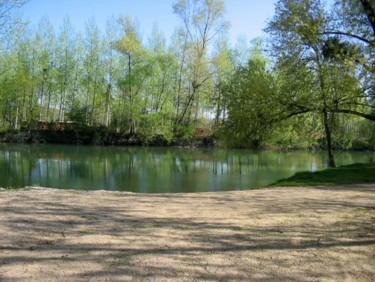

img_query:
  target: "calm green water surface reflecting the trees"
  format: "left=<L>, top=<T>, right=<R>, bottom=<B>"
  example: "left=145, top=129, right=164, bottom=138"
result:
left=0, top=144, right=375, bottom=193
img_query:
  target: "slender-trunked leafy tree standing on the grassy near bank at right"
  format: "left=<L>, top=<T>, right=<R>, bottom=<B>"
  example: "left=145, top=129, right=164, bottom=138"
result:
left=267, top=0, right=375, bottom=166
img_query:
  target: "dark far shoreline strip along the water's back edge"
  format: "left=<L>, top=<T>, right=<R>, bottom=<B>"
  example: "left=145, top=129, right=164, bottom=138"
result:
left=0, top=127, right=375, bottom=152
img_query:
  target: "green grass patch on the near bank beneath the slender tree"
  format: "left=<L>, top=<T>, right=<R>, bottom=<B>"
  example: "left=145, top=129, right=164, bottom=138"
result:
left=270, top=163, right=375, bottom=187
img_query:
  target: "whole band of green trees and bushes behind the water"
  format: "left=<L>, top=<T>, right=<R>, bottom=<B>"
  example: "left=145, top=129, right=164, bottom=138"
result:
left=0, top=0, right=375, bottom=160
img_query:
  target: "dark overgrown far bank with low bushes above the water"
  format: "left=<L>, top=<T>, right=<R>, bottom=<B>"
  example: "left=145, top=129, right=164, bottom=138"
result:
left=0, top=128, right=375, bottom=151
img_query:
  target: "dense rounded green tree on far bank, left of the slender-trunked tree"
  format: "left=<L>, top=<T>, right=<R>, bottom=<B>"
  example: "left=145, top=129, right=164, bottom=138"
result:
left=220, top=42, right=275, bottom=147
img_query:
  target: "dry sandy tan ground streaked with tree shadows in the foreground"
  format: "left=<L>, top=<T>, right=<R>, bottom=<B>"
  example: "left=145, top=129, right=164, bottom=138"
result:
left=0, top=185, right=375, bottom=281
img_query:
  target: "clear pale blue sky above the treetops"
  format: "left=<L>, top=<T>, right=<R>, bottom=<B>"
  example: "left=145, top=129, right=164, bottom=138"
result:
left=23, top=0, right=276, bottom=43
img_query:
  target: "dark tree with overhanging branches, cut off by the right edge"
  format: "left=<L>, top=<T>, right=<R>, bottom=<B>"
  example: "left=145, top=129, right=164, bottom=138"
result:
left=322, top=0, right=375, bottom=114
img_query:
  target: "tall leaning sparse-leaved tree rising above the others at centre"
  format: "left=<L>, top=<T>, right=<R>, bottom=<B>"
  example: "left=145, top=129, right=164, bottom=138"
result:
left=173, top=0, right=228, bottom=128
